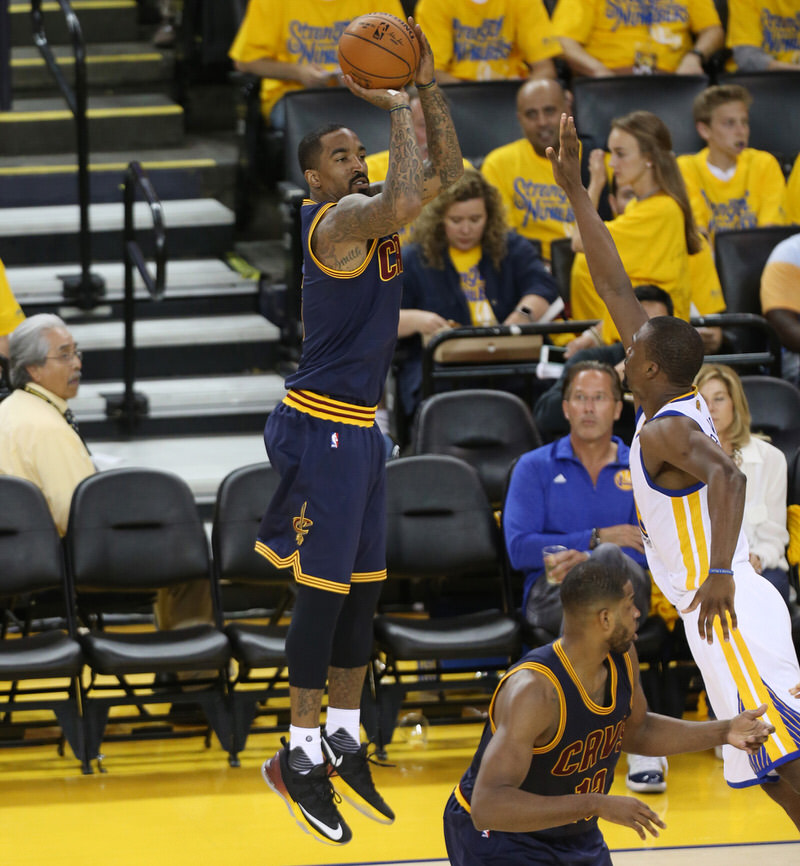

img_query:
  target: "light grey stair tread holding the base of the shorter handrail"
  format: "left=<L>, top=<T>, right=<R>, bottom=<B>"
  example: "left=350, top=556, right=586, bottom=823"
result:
left=70, top=373, right=286, bottom=421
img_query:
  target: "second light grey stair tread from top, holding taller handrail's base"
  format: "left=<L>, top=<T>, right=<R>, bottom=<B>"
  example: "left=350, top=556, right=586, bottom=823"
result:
left=6, top=259, right=256, bottom=308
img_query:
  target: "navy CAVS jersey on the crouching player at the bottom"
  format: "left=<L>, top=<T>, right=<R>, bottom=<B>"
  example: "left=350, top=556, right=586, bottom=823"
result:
left=455, top=640, right=635, bottom=838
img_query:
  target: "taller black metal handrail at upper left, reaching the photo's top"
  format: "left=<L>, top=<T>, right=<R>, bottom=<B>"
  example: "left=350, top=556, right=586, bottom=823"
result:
left=31, top=0, right=105, bottom=310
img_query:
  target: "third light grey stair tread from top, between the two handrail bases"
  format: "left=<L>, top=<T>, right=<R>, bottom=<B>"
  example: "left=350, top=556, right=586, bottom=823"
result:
left=70, top=313, right=280, bottom=350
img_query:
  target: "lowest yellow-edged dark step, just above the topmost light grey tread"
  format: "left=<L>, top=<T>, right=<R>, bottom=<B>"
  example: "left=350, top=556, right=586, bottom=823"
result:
left=0, top=132, right=238, bottom=207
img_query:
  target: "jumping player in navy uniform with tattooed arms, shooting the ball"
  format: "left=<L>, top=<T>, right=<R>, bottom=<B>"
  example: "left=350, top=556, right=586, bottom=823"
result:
left=256, top=18, right=462, bottom=844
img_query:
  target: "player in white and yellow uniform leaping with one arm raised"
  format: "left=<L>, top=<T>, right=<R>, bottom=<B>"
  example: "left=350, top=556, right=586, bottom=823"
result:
left=547, top=115, right=800, bottom=828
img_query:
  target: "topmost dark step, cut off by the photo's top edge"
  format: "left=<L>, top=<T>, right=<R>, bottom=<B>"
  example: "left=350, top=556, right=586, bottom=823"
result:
left=8, top=0, right=138, bottom=46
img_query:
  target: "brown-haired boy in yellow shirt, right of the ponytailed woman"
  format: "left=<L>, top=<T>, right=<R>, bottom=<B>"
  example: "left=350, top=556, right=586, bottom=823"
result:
left=678, top=84, right=787, bottom=242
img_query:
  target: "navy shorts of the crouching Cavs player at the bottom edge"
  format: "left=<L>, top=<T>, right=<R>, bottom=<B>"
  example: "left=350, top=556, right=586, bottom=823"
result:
left=444, top=794, right=612, bottom=866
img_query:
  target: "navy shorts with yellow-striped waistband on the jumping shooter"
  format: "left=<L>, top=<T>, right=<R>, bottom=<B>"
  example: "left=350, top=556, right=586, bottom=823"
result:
left=256, top=391, right=386, bottom=595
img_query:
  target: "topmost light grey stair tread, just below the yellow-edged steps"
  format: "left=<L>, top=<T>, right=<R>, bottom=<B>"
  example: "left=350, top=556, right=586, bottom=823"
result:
left=0, top=199, right=235, bottom=237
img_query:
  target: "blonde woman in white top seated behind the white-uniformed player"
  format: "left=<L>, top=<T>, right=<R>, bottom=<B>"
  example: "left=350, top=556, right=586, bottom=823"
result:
left=694, top=364, right=789, bottom=602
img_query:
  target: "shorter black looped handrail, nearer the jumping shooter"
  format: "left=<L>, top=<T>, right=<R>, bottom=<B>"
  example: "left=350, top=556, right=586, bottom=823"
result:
left=106, top=161, right=167, bottom=433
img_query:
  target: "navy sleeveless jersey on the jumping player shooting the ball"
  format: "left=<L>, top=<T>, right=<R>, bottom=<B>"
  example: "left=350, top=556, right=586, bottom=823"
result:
left=286, top=200, right=403, bottom=406
